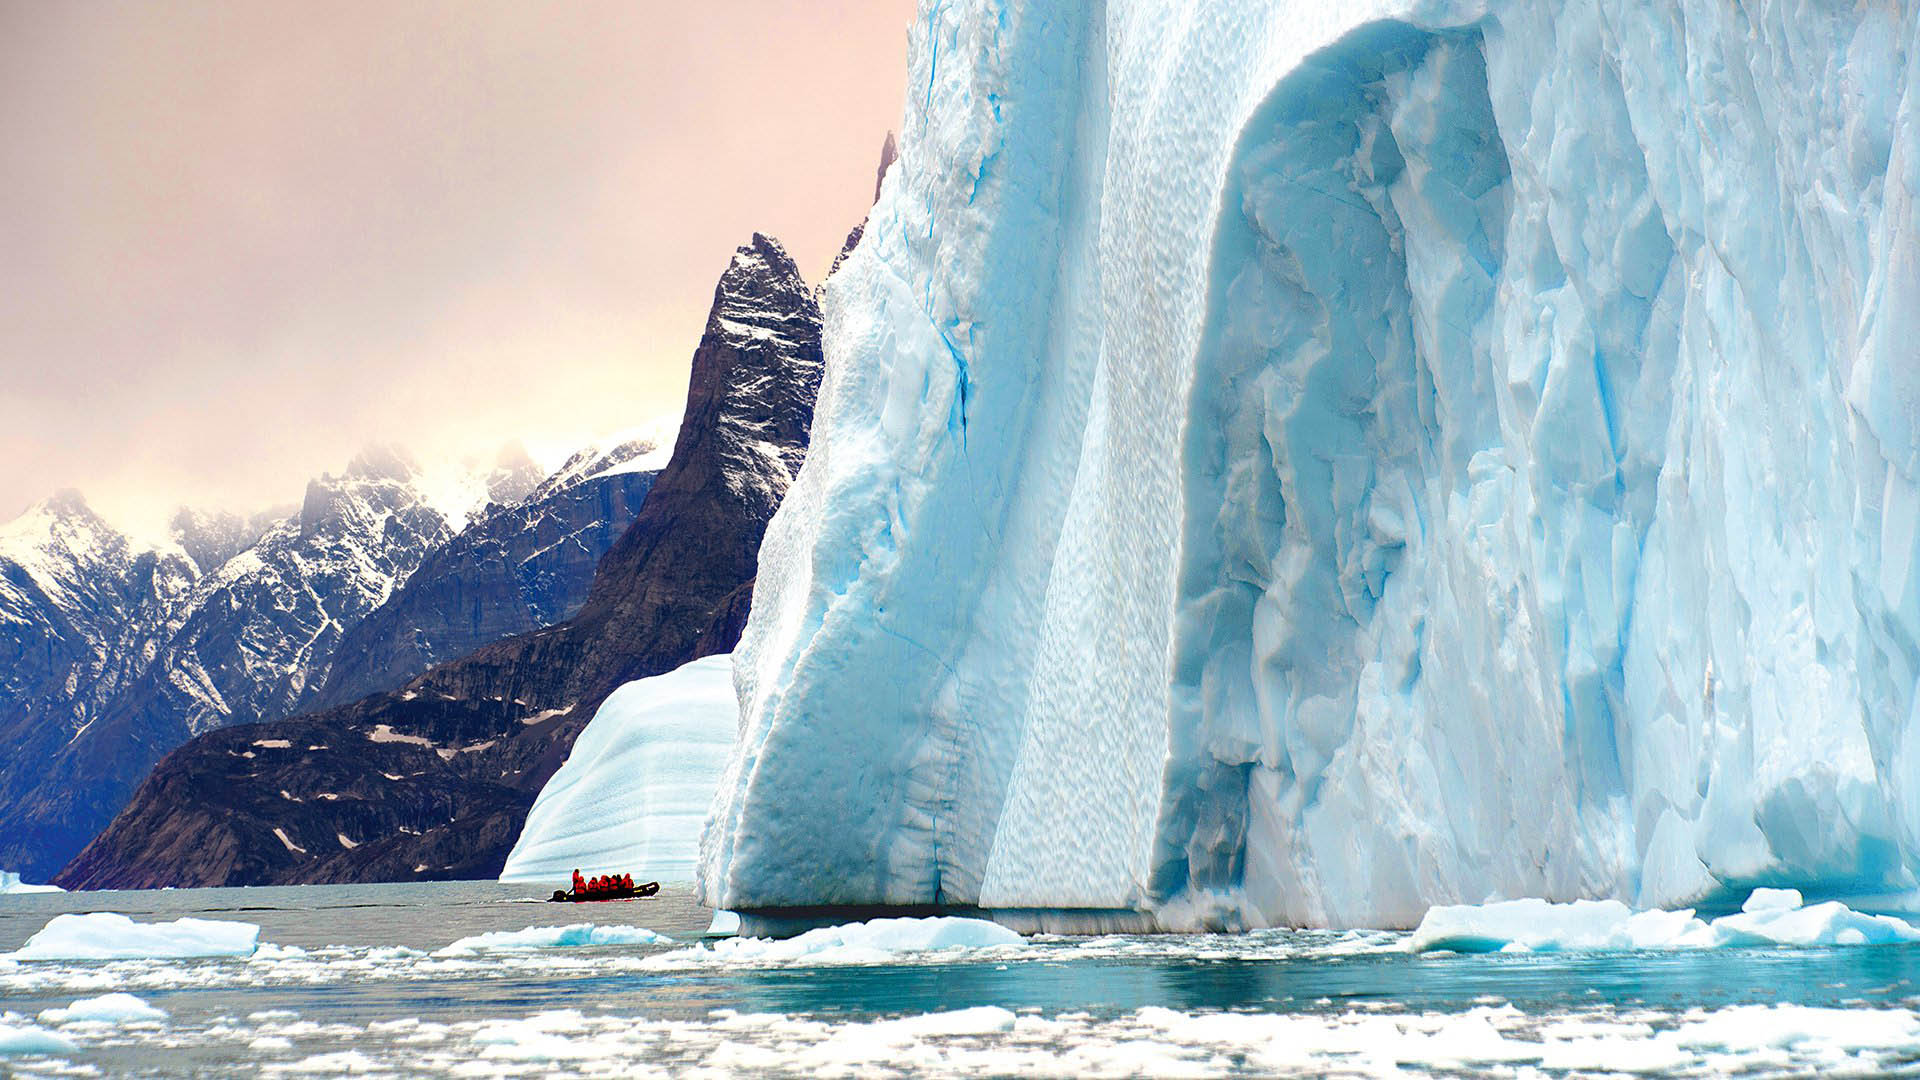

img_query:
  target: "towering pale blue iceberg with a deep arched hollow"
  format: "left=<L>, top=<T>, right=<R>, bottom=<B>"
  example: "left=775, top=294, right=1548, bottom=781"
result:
left=701, top=0, right=1920, bottom=926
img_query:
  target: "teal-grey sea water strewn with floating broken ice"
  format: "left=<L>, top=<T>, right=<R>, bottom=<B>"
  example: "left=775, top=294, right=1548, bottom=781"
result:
left=0, top=882, right=1920, bottom=1076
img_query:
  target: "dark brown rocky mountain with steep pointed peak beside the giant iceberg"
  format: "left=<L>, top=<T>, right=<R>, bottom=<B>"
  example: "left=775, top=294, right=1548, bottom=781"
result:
left=56, top=234, right=820, bottom=888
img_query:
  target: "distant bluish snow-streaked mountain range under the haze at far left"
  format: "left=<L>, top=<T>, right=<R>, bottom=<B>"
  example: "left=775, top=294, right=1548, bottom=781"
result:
left=0, top=432, right=647, bottom=878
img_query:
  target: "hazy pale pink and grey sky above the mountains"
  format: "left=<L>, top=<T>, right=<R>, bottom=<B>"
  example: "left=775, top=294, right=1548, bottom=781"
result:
left=0, top=0, right=912, bottom=527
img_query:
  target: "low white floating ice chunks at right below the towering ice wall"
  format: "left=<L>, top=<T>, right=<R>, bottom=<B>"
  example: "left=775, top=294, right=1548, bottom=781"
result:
left=1407, top=888, right=1920, bottom=953
